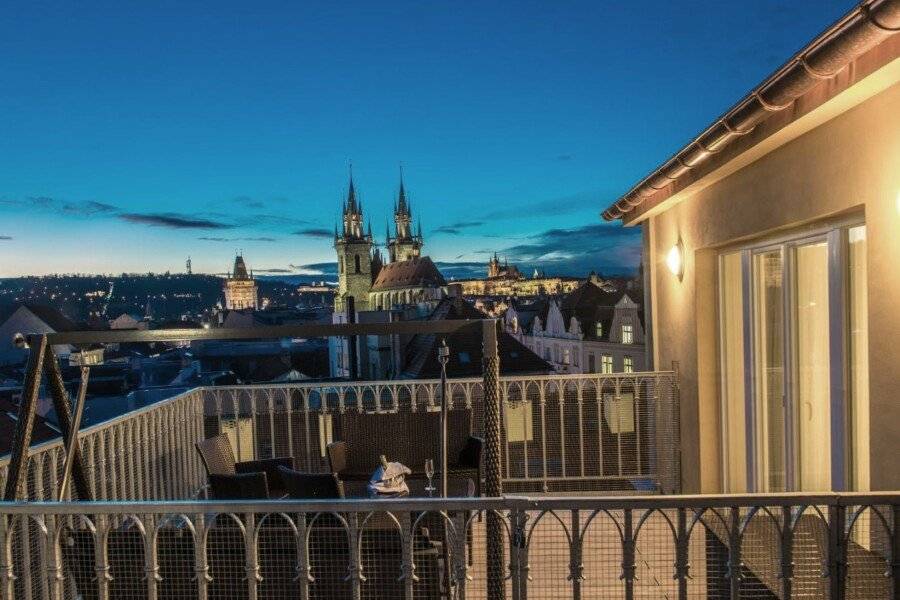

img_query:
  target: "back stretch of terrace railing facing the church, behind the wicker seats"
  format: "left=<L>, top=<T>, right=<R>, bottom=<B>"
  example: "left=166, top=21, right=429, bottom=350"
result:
left=203, top=372, right=680, bottom=493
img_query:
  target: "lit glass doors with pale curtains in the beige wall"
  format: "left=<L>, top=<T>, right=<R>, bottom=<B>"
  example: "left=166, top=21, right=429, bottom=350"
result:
left=718, top=223, right=869, bottom=492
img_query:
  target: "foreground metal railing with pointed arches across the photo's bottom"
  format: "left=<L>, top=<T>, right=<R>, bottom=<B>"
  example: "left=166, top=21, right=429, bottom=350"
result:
left=0, top=493, right=900, bottom=600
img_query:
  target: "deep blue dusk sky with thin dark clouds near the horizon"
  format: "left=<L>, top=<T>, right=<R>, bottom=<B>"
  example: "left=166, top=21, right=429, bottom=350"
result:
left=0, top=0, right=853, bottom=277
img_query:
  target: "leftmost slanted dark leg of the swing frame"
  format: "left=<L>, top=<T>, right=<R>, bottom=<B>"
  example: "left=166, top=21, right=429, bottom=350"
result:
left=3, top=335, right=47, bottom=502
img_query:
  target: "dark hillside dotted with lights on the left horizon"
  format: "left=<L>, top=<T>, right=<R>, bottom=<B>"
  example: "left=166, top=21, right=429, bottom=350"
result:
left=0, top=273, right=300, bottom=322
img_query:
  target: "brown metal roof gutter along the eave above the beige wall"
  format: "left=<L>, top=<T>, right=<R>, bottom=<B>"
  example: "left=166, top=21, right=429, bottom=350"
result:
left=602, top=0, right=900, bottom=221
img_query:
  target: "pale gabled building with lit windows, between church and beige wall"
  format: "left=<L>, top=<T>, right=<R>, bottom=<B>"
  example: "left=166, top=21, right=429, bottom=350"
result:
left=504, top=279, right=647, bottom=373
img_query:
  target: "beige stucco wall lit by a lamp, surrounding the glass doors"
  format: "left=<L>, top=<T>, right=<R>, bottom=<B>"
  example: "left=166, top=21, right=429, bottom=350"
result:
left=648, top=79, right=900, bottom=492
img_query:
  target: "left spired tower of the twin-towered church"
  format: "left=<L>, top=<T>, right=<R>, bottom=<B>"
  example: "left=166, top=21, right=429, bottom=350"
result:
left=334, top=172, right=373, bottom=312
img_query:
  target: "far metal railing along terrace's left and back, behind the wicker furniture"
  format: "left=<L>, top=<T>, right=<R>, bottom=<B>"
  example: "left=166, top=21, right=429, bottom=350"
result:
left=0, top=372, right=680, bottom=500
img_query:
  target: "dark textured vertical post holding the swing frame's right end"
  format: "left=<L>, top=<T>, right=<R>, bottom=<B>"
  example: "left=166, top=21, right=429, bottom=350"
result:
left=482, top=319, right=506, bottom=600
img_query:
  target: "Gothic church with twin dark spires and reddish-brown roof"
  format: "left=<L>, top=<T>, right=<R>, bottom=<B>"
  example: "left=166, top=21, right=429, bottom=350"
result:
left=334, top=174, right=448, bottom=314
